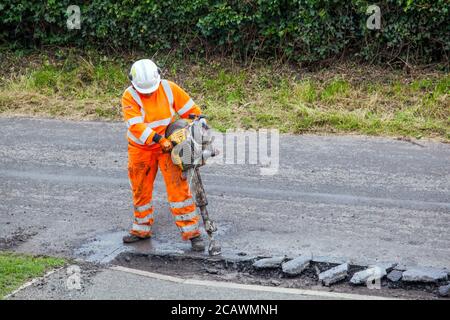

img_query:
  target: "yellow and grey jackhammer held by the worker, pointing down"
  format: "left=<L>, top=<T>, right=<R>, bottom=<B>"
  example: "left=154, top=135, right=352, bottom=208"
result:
left=165, top=114, right=221, bottom=256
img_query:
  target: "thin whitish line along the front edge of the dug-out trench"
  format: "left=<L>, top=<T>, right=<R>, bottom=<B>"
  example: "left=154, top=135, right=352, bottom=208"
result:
left=109, top=266, right=394, bottom=300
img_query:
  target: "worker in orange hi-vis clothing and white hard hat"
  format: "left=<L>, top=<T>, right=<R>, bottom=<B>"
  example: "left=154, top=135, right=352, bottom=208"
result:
left=122, top=59, right=205, bottom=251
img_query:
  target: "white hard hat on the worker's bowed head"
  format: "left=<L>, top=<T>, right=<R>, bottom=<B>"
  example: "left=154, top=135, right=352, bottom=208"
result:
left=129, top=59, right=161, bottom=94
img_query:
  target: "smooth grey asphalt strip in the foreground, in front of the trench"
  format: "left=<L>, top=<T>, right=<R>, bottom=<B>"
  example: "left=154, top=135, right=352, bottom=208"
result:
left=7, top=267, right=358, bottom=302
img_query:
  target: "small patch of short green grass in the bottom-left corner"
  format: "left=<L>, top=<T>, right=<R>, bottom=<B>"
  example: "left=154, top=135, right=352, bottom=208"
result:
left=0, top=252, right=65, bottom=299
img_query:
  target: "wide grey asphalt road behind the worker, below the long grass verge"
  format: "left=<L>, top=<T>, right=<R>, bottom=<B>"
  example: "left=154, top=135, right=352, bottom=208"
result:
left=0, top=118, right=450, bottom=267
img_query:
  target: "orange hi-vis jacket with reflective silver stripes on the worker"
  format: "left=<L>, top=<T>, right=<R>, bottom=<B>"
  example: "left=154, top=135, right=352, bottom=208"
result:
left=122, top=80, right=201, bottom=150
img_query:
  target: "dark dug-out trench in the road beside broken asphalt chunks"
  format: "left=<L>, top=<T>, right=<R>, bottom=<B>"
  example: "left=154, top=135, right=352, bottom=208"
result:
left=112, top=252, right=446, bottom=299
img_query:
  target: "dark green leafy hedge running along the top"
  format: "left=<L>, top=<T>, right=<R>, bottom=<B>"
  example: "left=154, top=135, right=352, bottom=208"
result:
left=0, top=0, right=450, bottom=63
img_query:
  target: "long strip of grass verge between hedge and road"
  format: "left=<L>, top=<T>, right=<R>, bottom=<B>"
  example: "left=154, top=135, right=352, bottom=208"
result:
left=0, top=49, right=450, bottom=141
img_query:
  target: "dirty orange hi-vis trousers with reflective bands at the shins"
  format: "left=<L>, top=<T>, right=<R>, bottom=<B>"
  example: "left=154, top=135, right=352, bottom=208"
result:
left=128, top=144, right=200, bottom=240
